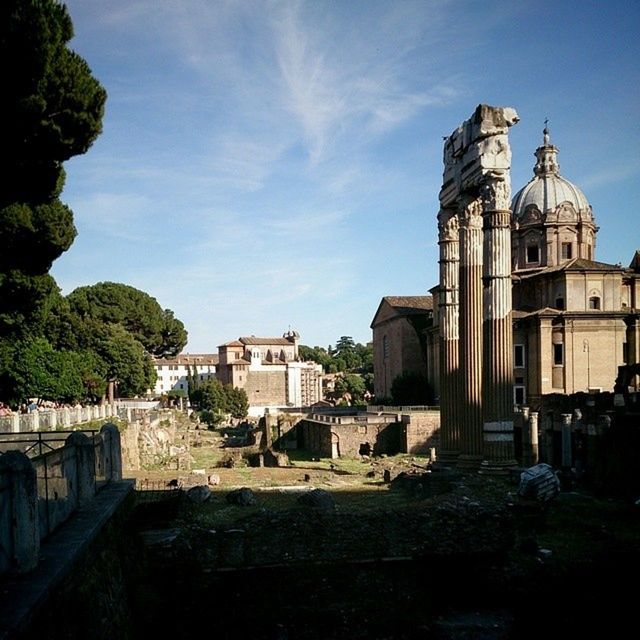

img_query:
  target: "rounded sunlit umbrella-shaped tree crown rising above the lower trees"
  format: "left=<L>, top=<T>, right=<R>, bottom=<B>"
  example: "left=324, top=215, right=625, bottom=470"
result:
left=67, top=282, right=187, bottom=358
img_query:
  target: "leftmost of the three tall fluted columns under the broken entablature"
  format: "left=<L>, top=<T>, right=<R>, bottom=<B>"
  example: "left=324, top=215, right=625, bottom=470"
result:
left=438, top=208, right=460, bottom=462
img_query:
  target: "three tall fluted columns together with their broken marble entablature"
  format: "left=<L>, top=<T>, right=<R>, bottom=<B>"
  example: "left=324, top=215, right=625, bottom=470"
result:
left=438, top=105, right=518, bottom=472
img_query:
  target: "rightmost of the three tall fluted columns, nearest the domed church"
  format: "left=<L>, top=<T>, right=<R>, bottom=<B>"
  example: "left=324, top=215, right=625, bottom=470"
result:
left=480, top=172, right=517, bottom=472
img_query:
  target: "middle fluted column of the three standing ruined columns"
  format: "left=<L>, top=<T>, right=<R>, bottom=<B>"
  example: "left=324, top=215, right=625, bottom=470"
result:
left=458, top=198, right=483, bottom=468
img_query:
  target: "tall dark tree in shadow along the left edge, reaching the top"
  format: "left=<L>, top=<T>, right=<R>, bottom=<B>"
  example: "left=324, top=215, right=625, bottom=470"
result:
left=0, top=0, right=106, bottom=339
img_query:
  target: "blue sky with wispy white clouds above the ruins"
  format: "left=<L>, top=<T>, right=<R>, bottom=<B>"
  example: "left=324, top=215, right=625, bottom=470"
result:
left=51, top=0, right=640, bottom=352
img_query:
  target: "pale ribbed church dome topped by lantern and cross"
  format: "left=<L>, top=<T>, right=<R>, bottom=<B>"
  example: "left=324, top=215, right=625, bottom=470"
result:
left=511, top=128, right=593, bottom=221
